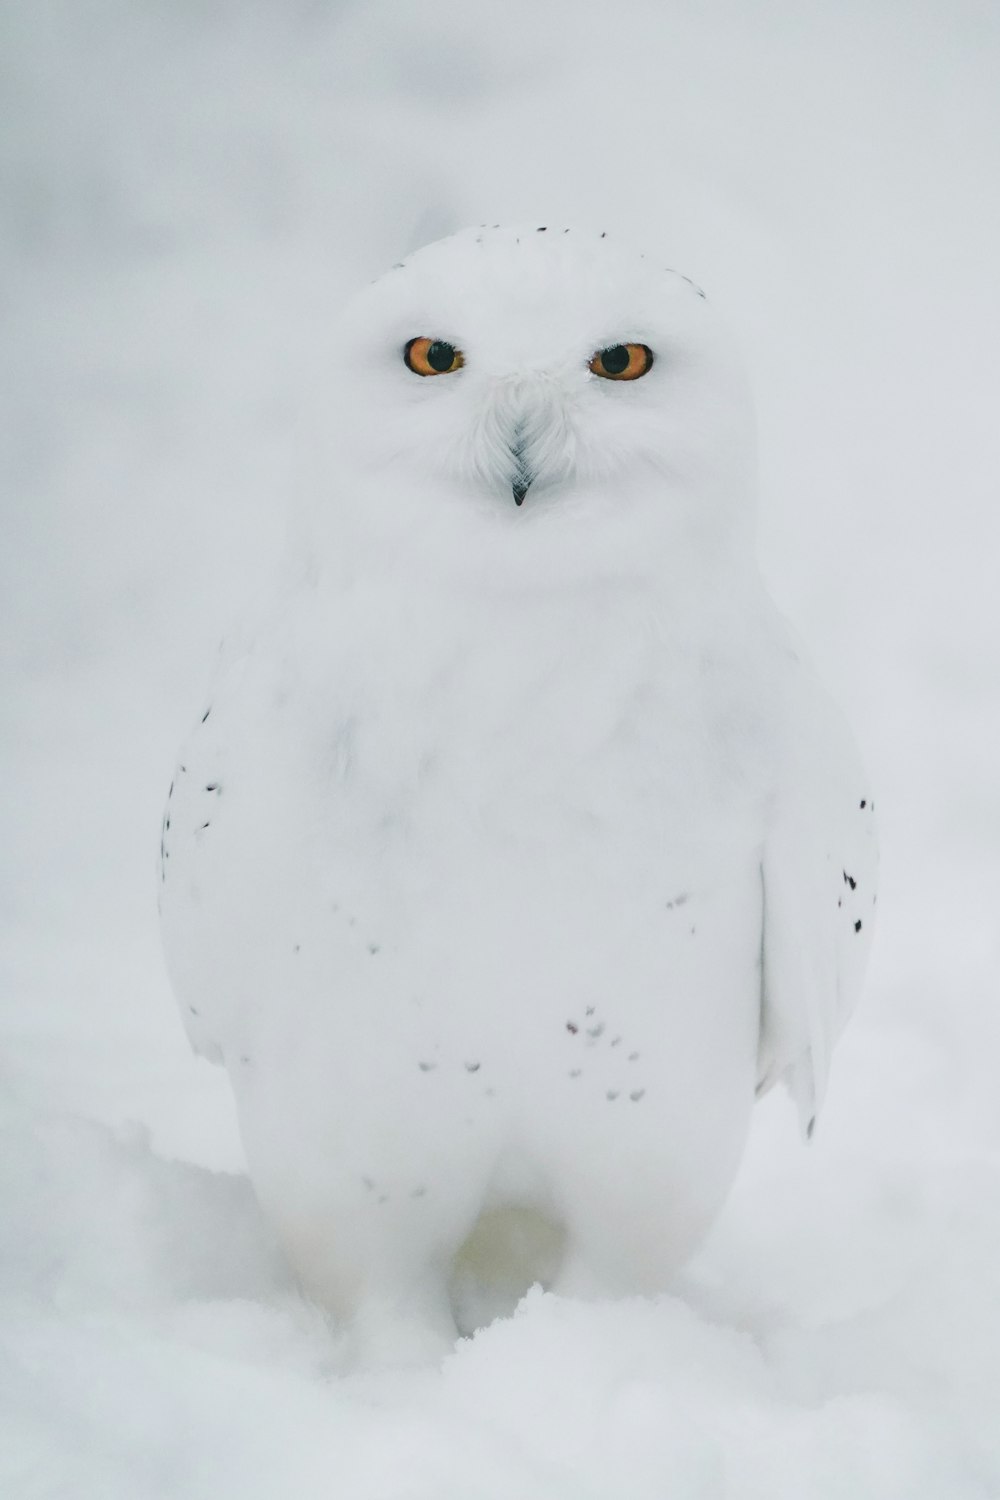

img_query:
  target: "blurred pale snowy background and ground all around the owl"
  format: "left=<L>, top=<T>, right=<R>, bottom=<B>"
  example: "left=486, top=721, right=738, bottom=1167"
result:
left=0, top=0, right=1000, bottom=1500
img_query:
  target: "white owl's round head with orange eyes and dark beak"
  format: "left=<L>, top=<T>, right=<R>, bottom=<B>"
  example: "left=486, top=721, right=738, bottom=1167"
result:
left=322, top=227, right=753, bottom=591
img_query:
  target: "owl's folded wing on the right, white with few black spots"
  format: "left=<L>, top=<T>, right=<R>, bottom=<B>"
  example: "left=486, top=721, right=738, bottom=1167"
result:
left=757, top=657, right=879, bottom=1134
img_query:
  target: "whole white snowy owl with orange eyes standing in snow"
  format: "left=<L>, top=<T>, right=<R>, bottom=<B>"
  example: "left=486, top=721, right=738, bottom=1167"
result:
left=160, top=227, right=876, bottom=1347
